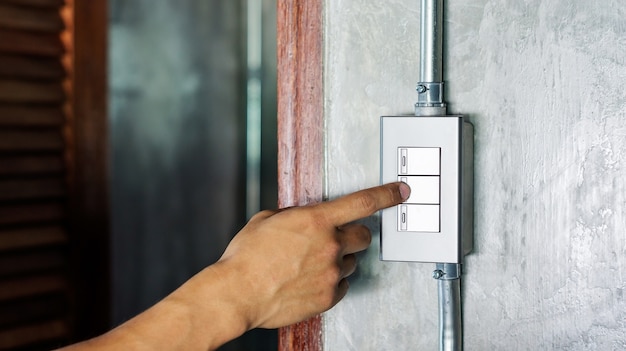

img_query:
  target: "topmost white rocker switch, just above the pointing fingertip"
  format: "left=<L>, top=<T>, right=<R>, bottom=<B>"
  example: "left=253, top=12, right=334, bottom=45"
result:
left=398, top=147, right=441, bottom=175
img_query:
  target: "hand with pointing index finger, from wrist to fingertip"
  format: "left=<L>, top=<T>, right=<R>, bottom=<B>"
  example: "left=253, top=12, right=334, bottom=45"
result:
left=215, top=183, right=410, bottom=328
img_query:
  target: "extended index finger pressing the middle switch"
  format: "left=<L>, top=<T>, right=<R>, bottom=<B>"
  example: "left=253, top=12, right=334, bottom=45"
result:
left=318, top=182, right=411, bottom=226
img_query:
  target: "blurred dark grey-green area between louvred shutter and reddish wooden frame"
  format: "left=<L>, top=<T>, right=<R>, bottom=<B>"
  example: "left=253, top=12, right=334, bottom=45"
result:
left=109, top=0, right=277, bottom=350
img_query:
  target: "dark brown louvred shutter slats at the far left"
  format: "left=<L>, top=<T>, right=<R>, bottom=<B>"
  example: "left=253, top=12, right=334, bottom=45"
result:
left=0, top=0, right=106, bottom=350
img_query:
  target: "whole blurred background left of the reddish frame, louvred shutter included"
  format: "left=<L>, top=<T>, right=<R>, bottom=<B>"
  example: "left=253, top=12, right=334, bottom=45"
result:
left=0, top=0, right=277, bottom=350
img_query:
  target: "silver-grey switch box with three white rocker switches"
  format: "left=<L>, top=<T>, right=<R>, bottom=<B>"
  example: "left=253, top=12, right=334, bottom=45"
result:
left=380, top=116, right=473, bottom=263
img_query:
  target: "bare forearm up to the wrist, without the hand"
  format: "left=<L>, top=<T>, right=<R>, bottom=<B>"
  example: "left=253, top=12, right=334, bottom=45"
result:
left=63, top=264, right=250, bottom=351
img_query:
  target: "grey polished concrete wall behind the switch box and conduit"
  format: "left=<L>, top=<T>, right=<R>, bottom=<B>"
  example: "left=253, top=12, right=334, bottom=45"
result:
left=324, top=0, right=626, bottom=350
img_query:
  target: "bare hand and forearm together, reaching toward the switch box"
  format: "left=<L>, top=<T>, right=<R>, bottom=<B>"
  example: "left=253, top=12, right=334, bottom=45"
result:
left=62, top=183, right=410, bottom=351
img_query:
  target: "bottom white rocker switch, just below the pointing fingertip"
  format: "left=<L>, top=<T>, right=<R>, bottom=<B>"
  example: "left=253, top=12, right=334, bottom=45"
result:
left=398, top=204, right=440, bottom=233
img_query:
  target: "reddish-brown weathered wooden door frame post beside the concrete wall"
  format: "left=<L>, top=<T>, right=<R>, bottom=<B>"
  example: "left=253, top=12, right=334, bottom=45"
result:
left=277, top=0, right=324, bottom=351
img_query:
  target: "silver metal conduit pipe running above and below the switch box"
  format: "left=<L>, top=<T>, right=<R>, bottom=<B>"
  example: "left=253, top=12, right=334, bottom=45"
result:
left=415, top=0, right=463, bottom=351
